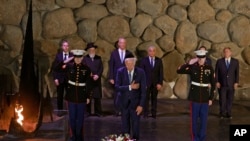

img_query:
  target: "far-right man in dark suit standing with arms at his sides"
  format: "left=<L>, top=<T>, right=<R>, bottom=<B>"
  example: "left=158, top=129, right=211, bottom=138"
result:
left=215, top=47, right=239, bottom=118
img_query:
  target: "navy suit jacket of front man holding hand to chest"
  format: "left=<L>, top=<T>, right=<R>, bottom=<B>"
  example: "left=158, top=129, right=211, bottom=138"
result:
left=115, top=67, right=146, bottom=108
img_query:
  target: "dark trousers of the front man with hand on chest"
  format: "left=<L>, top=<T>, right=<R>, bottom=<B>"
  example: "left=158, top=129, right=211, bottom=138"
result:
left=121, top=103, right=140, bottom=140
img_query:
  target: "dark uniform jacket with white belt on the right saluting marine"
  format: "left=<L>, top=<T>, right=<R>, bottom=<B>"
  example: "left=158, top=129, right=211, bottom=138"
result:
left=177, top=63, right=215, bottom=103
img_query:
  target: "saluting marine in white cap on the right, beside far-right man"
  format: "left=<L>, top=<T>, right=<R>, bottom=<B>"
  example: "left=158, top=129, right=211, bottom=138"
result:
left=177, top=50, right=215, bottom=141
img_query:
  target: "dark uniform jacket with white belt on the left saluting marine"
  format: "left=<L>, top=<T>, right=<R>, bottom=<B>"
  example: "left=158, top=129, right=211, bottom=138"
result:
left=65, top=63, right=91, bottom=103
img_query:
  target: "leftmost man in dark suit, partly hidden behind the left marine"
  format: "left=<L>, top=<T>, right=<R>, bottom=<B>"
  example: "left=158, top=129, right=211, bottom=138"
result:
left=52, top=40, right=73, bottom=116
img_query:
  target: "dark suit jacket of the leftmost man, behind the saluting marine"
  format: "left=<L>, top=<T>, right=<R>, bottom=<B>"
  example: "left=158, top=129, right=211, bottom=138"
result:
left=52, top=51, right=73, bottom=83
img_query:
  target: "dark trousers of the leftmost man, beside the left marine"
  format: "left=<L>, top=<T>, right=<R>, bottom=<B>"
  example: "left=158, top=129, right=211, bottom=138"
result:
left=57, top=82, right=68, bottom=110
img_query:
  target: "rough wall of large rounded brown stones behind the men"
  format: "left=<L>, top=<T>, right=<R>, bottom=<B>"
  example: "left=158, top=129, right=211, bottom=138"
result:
left=0, top=0, right=250, bottom=99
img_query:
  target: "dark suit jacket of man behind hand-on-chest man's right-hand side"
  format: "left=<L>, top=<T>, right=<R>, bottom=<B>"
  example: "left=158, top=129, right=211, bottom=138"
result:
left=140, top=56, right=163, bottom=87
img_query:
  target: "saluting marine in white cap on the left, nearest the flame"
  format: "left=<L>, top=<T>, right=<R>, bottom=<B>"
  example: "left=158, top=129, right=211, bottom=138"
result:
left=60, top=50, right=91, bottom=141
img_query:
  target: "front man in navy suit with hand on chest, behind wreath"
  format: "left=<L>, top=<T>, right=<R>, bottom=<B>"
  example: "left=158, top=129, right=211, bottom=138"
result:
left=115, top=55, right=146, bottom=140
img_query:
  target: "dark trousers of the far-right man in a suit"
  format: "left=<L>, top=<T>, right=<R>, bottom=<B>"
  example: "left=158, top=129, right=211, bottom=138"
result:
left=219, top=87, right=234, bottom=116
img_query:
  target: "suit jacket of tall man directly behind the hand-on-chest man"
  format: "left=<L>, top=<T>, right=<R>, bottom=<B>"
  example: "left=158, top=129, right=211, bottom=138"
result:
left=108, top=49, right=132, bottom=80
